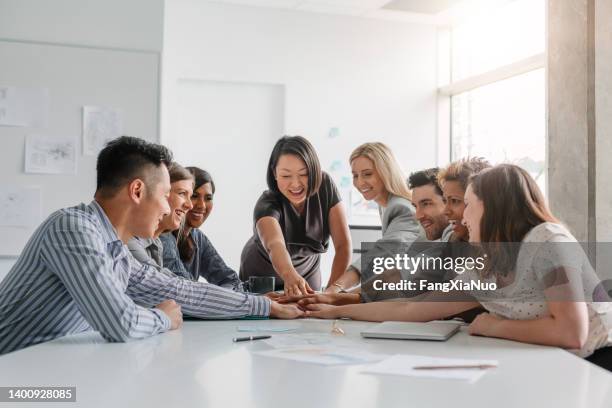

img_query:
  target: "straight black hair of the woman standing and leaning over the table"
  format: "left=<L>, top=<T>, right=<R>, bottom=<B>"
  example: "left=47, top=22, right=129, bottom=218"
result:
left=266, top=136, right=323, bottom=197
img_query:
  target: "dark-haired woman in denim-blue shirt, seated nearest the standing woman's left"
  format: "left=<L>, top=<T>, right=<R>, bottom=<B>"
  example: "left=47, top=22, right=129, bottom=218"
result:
left=160, top=167, right=242, bottom=291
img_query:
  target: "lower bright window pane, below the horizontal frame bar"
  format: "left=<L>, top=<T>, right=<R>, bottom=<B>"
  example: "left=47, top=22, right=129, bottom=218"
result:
left=451, top=69, right=546, bottom=192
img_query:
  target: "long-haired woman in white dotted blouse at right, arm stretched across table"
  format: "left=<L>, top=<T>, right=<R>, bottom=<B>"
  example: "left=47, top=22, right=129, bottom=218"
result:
left=307, top=165, right=612, bottom=368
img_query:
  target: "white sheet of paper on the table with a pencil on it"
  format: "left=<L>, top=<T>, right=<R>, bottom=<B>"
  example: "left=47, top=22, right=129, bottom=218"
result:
left=361, top=354, right=498, bottom=383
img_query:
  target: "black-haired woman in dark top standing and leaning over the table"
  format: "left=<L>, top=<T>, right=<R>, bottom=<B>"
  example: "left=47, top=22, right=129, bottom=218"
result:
left=240, top=136, right=351, bottom=296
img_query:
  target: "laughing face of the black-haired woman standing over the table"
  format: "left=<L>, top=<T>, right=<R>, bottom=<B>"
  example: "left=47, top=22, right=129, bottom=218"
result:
left=274, top=154, right=308, bottom=208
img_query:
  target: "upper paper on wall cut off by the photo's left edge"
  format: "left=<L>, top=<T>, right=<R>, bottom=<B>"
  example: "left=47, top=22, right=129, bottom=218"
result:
left=0, top=86, right=49, bottom=127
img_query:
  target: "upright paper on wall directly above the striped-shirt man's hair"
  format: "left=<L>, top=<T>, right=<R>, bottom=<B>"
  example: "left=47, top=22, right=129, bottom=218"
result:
left=83, top=106, right=123, bottom=156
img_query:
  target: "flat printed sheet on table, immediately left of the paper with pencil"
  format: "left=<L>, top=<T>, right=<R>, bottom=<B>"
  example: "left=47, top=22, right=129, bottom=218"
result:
left=255, top=346, right=386, bottom=365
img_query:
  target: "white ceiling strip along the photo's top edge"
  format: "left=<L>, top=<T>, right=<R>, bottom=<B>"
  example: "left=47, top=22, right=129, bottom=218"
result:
left=201, top=0, right=511, bottom=25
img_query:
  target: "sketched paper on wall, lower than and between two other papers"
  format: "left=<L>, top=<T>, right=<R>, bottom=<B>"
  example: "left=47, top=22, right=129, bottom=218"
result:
left=25, top=135, right=77, bottom=174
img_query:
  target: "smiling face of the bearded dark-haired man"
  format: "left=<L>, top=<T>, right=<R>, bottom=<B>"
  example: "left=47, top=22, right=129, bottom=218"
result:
left=412, top=184, right=448, bottom=241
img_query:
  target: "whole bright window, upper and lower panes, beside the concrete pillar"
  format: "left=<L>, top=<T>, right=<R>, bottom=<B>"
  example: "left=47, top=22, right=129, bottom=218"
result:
left=440, top=0, right=546, bottom=192
